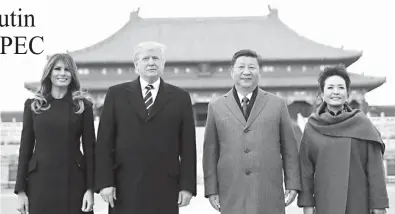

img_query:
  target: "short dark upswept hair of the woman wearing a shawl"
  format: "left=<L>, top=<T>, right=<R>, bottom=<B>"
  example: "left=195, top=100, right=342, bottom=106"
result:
left=318, top=65, right=351, bottom=93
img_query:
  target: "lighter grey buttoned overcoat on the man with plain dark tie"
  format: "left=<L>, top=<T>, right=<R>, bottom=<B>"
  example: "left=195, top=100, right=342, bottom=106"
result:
left=203, top=89, right=300, bottom=214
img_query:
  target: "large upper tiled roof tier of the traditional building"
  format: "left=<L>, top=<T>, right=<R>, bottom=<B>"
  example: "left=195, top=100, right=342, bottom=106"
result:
left=70, top=10, right=362, bottom=65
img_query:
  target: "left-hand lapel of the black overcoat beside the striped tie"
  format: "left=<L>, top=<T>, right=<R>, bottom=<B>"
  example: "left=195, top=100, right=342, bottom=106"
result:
left=125, top=78, right=146, bottom=120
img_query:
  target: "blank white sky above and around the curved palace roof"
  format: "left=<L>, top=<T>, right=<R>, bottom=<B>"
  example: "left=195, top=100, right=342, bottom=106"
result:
left=0, top=0, right=395, bottom=111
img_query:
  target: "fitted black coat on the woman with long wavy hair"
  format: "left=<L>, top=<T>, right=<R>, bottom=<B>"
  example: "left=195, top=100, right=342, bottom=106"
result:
left=15, top=93, right=95, bottom=214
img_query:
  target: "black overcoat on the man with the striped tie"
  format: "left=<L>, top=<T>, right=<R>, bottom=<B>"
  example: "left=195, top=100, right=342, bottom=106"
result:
left=95, top=78, right=196, bottom=214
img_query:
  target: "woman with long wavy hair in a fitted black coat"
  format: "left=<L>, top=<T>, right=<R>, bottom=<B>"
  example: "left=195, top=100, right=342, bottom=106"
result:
left=15, top=54, right=96, bottom=214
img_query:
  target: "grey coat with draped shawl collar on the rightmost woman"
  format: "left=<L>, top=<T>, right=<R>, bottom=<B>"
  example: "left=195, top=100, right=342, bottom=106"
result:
left=298, top=103, right=389, bottom=214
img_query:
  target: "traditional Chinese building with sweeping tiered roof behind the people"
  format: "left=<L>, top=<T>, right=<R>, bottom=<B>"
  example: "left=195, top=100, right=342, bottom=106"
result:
left=25, top=9, right=385, bottom=126
